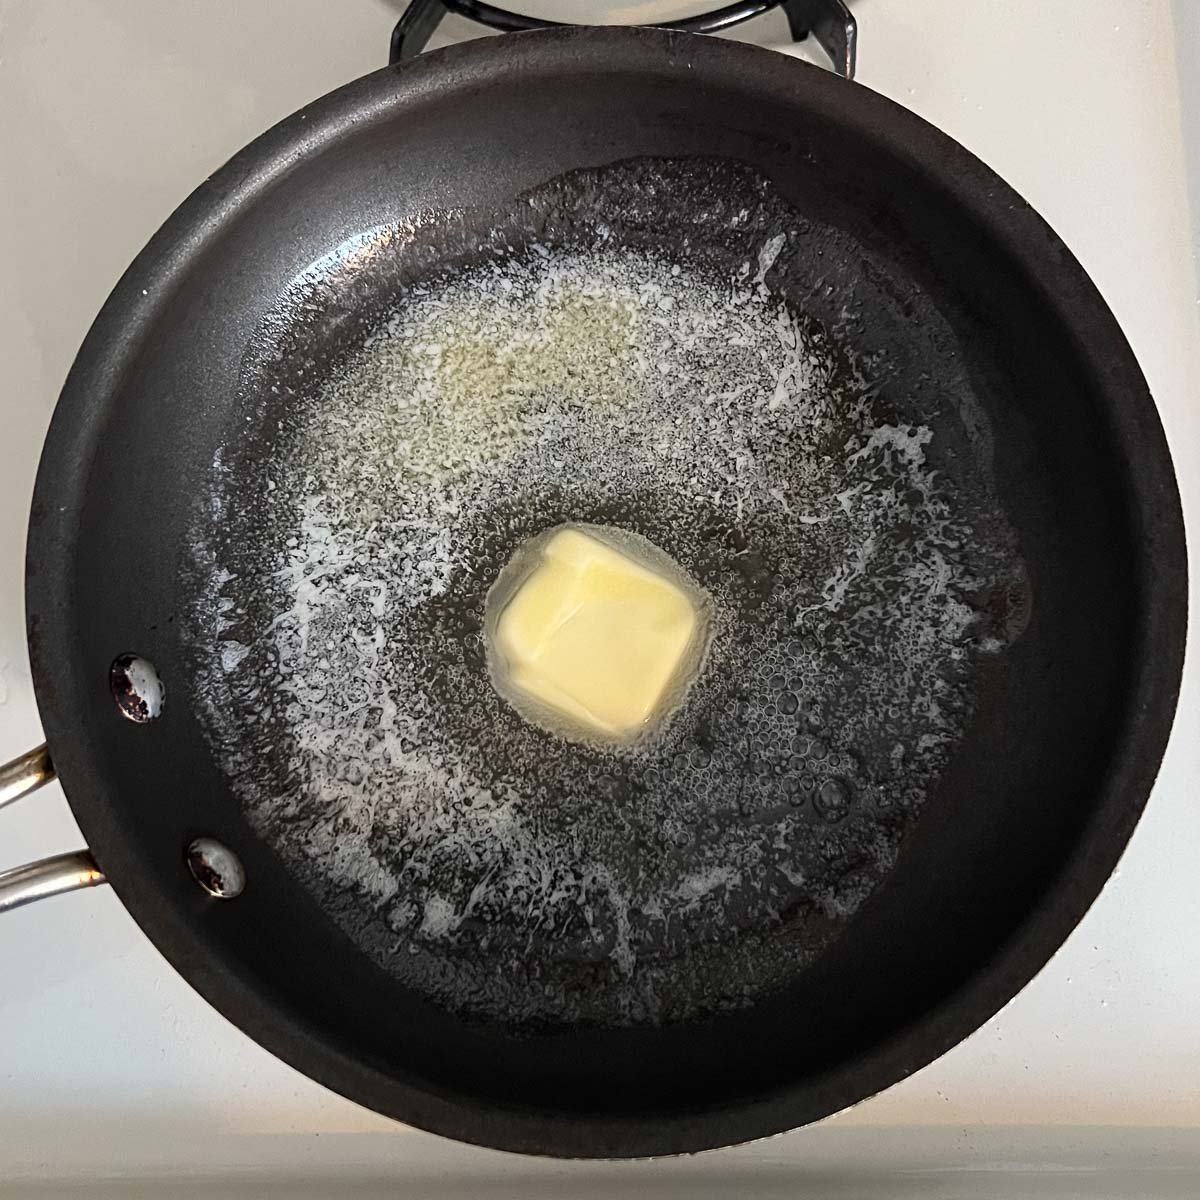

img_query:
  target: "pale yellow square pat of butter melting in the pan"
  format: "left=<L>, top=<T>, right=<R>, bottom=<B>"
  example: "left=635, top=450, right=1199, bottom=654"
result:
left=487, top=526, right=709, bottom=740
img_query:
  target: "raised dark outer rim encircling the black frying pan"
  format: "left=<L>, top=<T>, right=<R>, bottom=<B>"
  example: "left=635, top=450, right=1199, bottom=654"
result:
left=26, top=28, right=1187, bottom=1157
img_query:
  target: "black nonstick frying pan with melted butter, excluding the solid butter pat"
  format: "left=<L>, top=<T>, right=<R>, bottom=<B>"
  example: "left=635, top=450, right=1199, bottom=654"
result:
left=0, top=29, right=1186, bottom=1157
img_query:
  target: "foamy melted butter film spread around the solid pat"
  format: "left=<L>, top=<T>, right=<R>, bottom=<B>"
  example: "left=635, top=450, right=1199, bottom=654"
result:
left=182, top=160, right=1028, bottom=1027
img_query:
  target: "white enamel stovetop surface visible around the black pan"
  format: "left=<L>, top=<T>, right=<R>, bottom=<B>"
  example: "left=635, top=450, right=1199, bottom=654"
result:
left=0, top=0, right=1200, bottom=1196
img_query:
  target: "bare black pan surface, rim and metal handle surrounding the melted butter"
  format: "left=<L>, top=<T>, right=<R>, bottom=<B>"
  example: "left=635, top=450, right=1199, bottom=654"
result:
left=0, top=29, right=1186, bottom=1157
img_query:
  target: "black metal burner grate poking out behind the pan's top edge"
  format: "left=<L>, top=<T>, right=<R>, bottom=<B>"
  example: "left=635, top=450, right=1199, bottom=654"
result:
left=391, top=0, right=857, bottom=79
